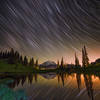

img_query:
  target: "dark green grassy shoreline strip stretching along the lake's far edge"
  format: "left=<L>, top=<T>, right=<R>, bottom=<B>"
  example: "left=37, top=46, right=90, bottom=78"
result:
left=0, top=60, right=100, bottom=74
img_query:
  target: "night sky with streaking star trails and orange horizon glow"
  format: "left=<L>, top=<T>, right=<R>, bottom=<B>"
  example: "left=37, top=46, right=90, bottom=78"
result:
left=0, top=0, right=100, bottom=63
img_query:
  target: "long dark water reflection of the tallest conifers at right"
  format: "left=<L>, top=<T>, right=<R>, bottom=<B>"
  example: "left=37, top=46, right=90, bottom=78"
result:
left=84, top=75, right=94, bottom=100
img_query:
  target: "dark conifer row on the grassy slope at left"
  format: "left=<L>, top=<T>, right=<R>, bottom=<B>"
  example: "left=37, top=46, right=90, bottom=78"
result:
left=0, top=48, right=38, bottom=67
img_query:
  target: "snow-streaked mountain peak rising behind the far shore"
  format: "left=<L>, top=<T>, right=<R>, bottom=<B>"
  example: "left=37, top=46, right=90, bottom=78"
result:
left=39, top=61, right=57, bottom=69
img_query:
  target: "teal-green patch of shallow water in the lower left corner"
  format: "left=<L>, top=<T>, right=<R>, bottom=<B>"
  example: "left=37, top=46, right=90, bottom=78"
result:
left=0, top=77, right=28, bottom=100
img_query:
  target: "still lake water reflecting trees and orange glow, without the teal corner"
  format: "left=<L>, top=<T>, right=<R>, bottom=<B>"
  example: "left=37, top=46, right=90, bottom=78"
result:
left=0, top=73, right=100, bottom=100
